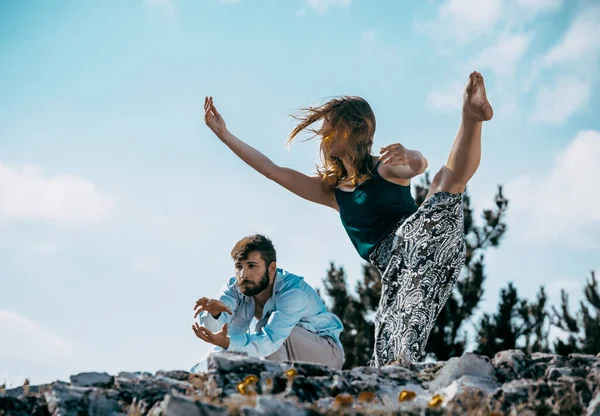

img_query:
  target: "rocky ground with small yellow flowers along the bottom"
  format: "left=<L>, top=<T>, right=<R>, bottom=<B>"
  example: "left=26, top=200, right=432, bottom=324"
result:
left=0, top=350, right=600, bottom=416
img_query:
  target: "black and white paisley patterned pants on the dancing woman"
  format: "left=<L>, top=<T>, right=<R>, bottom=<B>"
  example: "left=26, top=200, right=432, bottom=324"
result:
left=369, top=192, right=466, bottom=367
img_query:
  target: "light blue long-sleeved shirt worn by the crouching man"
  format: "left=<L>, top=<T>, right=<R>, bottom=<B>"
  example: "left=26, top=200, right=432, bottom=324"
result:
left=198, top=269, right=344, bottom=357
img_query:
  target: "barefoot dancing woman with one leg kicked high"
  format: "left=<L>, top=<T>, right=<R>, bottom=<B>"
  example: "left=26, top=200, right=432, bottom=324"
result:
left=204, top=72, right=493, bottom=367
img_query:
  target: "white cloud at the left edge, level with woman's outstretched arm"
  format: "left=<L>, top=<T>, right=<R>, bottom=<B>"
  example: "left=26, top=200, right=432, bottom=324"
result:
left=0, top=163, right=115, bottom=223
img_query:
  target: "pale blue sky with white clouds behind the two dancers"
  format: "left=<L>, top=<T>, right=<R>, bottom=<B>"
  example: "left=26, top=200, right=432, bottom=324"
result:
left=0, top=0, right=600, bottom=384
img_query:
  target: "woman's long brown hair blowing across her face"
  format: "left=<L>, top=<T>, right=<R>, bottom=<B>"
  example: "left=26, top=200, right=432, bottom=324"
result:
left=286, top=96, right=375, bottom=192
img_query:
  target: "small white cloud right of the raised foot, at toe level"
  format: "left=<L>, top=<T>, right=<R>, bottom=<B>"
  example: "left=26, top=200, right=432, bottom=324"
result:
left=531, top=77, right=592, bottom=124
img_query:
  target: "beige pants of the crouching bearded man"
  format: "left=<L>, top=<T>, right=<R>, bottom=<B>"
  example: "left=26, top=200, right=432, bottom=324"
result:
left=265, top=326, right=344, bottom=370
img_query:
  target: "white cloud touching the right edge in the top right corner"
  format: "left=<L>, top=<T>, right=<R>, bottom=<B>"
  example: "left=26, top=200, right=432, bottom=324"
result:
left=544, top=6, right=600, bottom=67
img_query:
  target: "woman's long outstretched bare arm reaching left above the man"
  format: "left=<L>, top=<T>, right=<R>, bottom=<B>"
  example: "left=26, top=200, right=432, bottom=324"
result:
left=205, top=98, right=337, bottom=209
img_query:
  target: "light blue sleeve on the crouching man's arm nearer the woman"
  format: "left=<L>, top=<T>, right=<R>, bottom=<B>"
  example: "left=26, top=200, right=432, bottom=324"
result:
left=227, top=289, right=306, bottom=357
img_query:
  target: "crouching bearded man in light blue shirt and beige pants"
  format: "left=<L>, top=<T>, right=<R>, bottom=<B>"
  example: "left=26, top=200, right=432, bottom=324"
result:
left=190, top=234, right=344, bottom=372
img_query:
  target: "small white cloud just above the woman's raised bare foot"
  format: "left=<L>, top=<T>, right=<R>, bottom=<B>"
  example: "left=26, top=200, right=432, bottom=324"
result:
left=467, top=33, right=533, bottom=76
